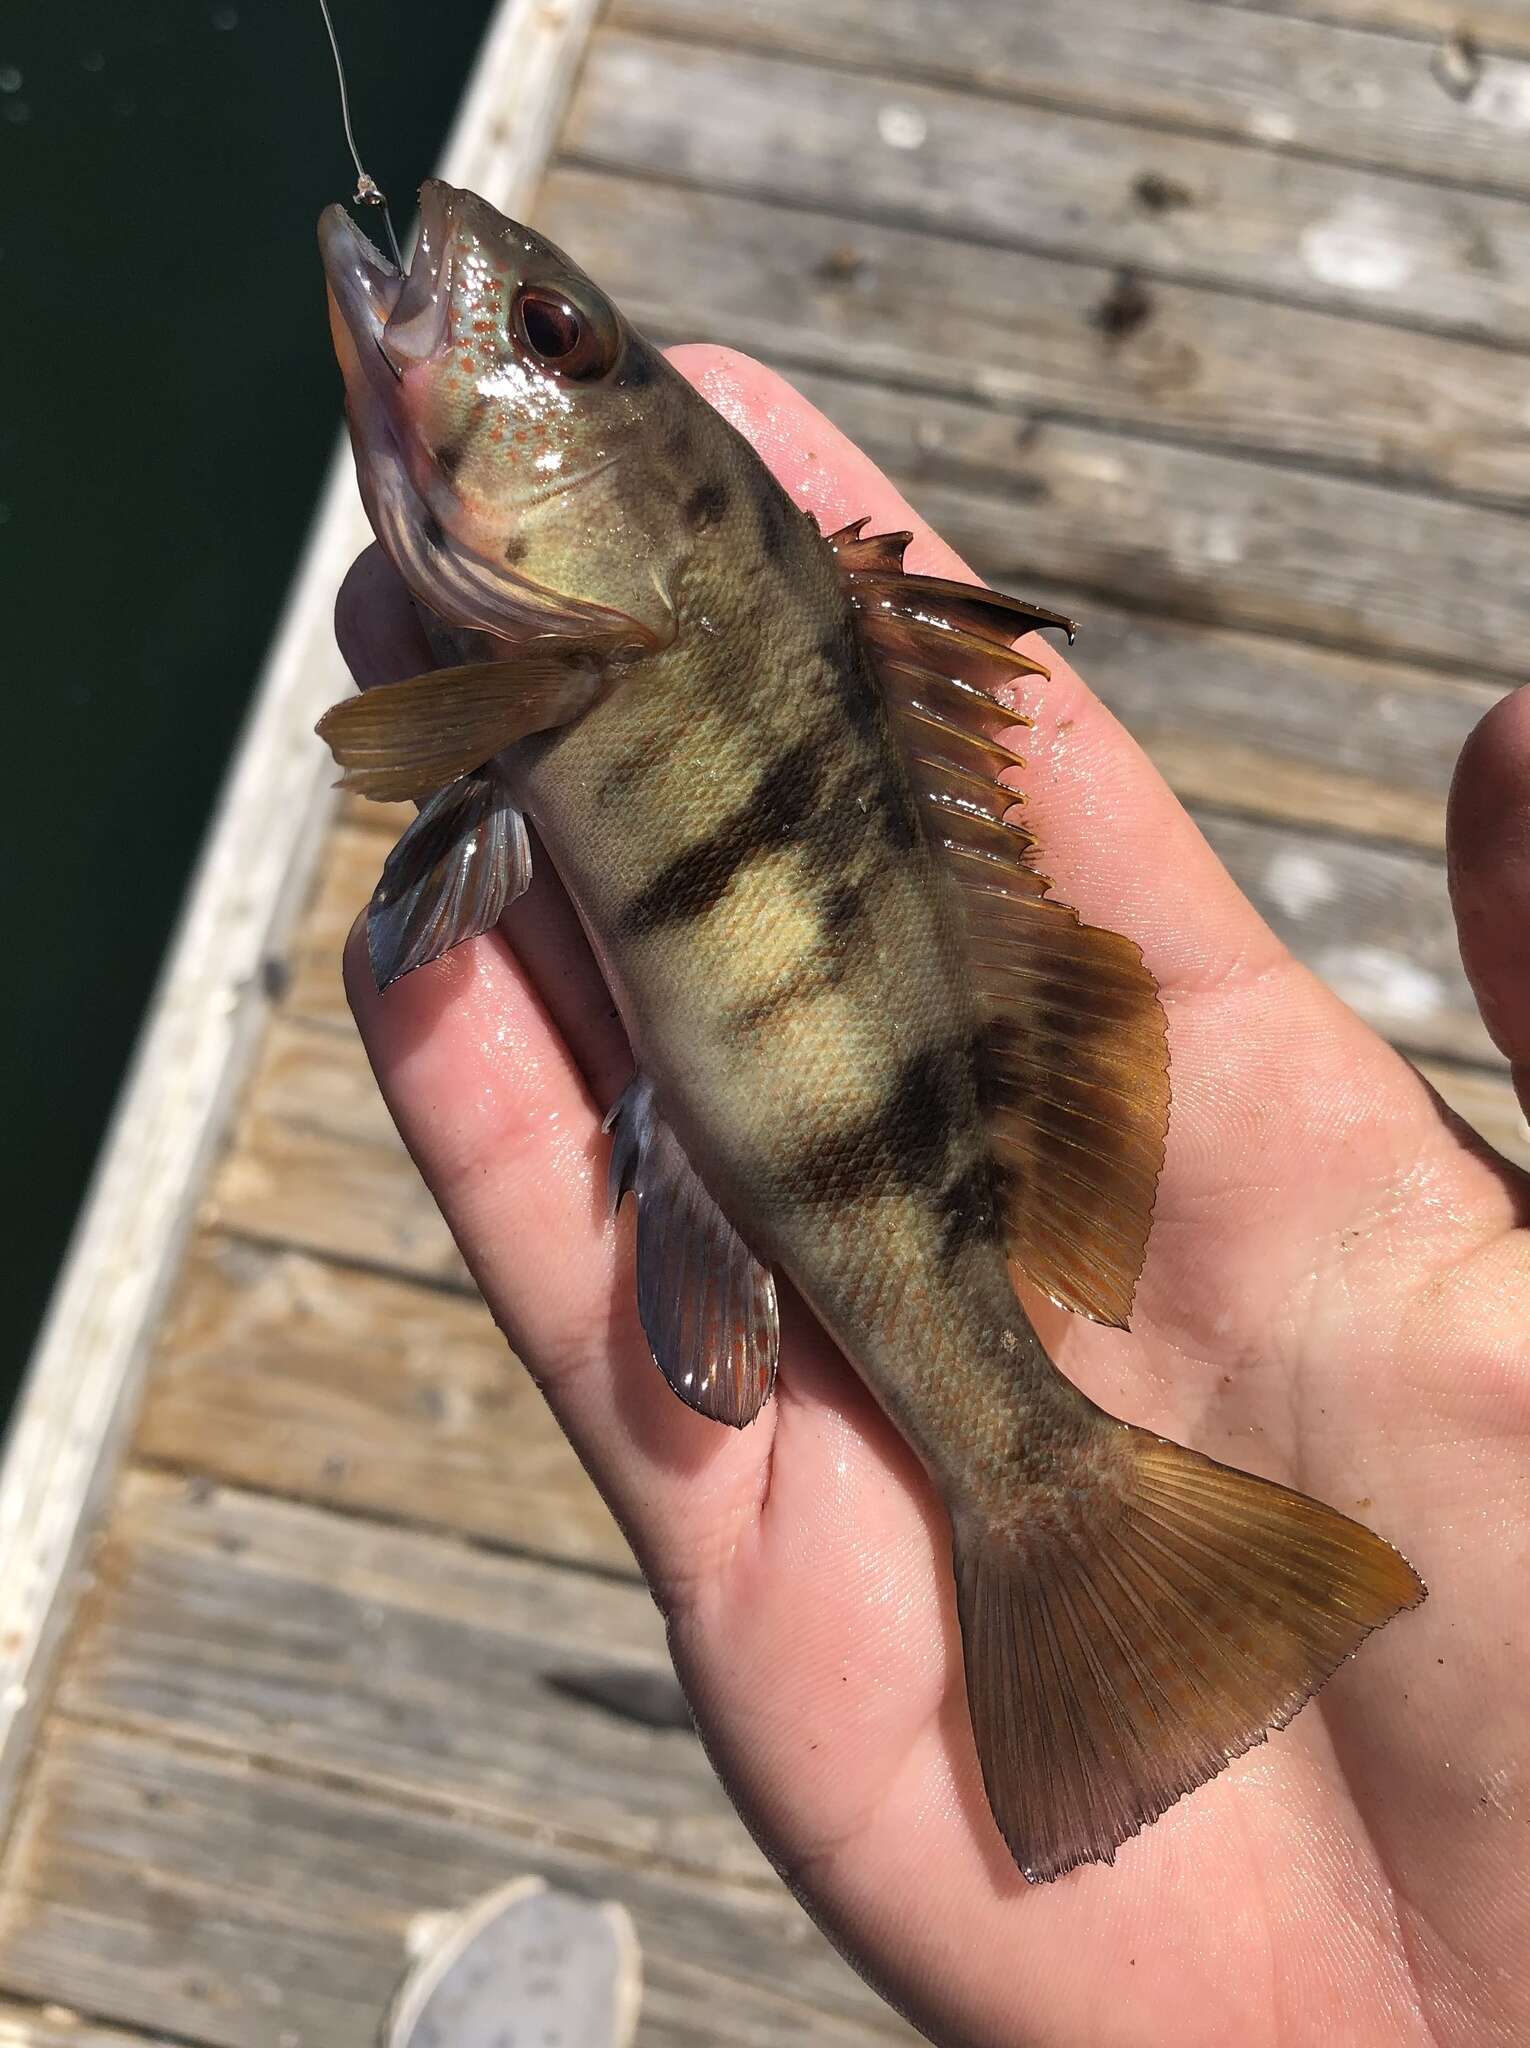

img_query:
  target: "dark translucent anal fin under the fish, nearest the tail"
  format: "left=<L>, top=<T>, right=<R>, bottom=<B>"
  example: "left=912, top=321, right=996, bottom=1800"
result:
left=606, top=1073, right=780, bottom=1430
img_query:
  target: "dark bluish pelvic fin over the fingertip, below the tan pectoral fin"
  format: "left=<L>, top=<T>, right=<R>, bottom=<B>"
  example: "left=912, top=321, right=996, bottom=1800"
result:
left=367, top=770, right=530, bottom=989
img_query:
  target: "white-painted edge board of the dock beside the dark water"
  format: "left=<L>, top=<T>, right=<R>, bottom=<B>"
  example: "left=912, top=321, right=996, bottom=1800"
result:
left=0, top=0, right=610, bottom=1859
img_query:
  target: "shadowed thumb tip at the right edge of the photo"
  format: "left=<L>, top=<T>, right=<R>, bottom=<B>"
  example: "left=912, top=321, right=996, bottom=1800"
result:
left=1446, top=688, right=1530, bottom=1094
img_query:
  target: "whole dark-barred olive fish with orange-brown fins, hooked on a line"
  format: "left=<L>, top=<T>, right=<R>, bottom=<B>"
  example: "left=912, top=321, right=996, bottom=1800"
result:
left=320, top=182, right=1426, bottom=1882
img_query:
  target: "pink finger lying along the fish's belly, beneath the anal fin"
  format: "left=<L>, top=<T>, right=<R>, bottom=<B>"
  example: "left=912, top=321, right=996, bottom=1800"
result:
left=346, top=928, right=774, bottom=1597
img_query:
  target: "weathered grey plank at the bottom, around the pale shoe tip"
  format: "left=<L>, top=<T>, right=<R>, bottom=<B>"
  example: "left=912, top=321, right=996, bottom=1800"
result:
left=0, top=1720, right=916, bottom=2048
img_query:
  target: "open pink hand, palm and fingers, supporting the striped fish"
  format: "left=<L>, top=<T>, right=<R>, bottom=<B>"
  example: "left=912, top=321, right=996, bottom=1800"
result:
left=337, top=352, right=1530, bottom=2044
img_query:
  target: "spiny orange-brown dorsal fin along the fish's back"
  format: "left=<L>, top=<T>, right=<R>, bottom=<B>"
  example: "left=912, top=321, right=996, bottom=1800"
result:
left=830, top=520, right=1170, bottom=1327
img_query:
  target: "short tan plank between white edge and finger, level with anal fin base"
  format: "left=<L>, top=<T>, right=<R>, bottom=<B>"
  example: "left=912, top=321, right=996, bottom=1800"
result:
left=207, top=1018, right=471, bottom=1290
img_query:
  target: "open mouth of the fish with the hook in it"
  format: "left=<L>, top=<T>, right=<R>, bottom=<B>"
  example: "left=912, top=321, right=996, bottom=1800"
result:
left=320, top=178, right=457, bottom=381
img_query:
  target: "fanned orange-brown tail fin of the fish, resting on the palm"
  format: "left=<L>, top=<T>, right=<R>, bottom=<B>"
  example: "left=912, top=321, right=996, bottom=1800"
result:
left=957, top=1423, right=1423, bottom=1884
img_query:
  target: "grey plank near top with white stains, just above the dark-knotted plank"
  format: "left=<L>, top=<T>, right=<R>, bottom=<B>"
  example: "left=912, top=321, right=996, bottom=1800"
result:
left=563, top=29, right=1530, bottom=348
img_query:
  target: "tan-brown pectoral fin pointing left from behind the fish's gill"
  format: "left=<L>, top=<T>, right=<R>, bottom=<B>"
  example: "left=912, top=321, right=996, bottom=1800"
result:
left=317, top=657, right=600, bottom=803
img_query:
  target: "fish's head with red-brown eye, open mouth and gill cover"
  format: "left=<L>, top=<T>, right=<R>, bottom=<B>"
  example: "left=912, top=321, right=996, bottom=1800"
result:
left=320, top=180, right=678, bottom=649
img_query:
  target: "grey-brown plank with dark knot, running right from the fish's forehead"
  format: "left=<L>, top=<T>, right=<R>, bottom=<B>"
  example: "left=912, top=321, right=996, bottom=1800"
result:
left=539, top=164, right=1530, bottom=504
